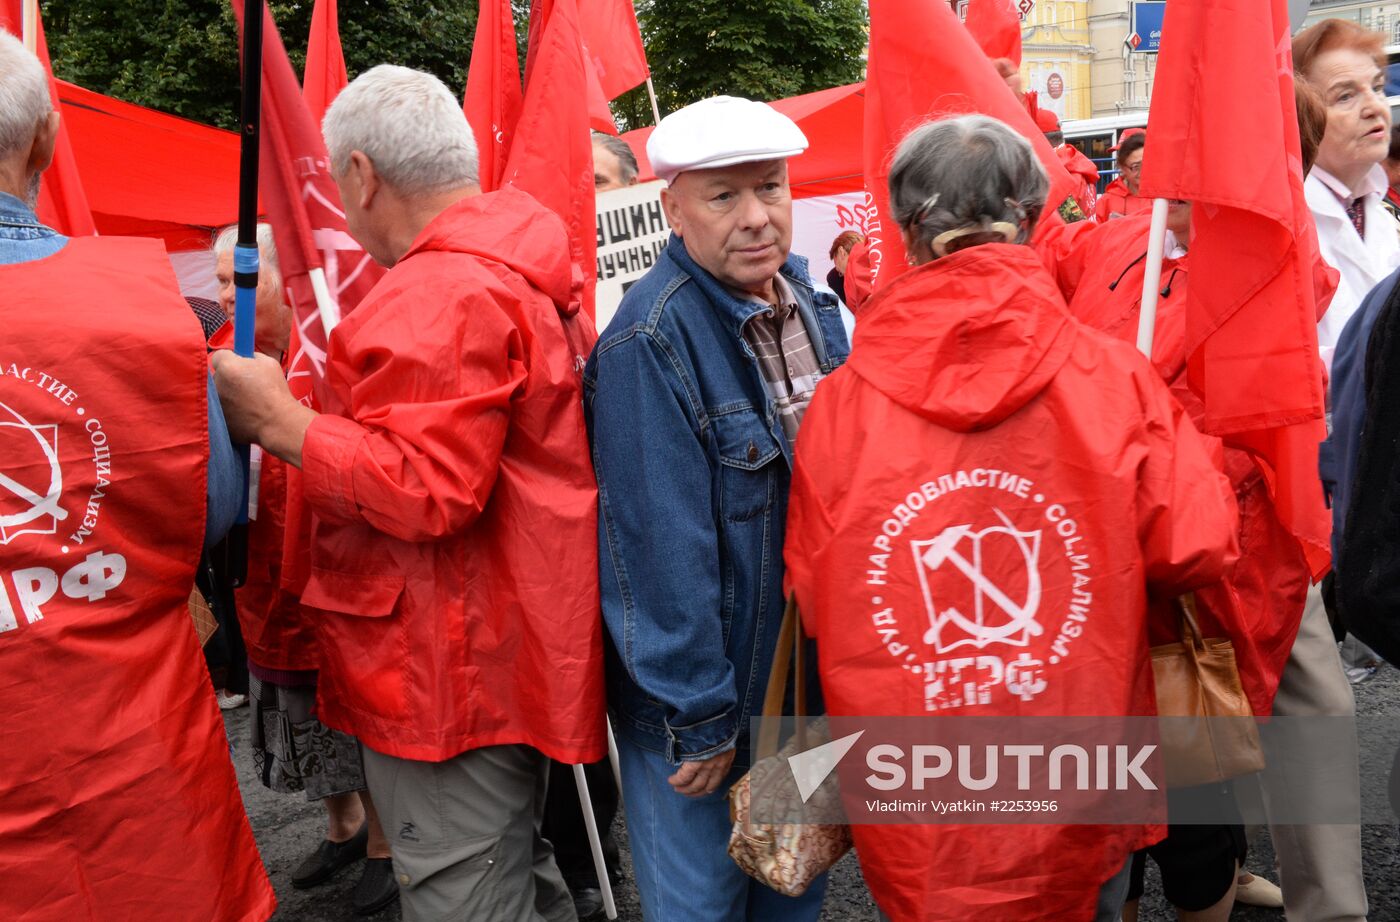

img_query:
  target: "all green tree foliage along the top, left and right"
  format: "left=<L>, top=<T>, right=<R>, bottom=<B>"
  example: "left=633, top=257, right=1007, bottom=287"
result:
left=42, top=0, right=867, bottom=129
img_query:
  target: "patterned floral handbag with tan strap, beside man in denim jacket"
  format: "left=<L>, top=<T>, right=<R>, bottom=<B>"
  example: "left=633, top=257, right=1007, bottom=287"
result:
left=729, top=597, right=851, bottom=897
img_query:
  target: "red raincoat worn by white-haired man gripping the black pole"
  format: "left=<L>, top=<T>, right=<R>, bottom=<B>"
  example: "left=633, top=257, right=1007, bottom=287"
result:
left=301, top=189, right=606, bottom=763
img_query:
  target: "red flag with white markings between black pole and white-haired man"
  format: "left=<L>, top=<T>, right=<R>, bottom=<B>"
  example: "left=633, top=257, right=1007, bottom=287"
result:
left=231, top=0, right=384, bottom=397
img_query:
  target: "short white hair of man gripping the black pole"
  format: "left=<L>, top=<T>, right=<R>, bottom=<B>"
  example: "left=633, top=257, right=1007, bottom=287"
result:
left=321, top=64, right=476, bottom=196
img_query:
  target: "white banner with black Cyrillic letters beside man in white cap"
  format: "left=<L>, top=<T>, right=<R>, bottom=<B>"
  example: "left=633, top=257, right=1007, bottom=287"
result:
left=594, top=179, right=671, bottom=334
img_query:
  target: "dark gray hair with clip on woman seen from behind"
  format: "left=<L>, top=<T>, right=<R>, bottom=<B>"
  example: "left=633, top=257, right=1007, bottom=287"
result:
left=889, top=115, right=1050, bottom=260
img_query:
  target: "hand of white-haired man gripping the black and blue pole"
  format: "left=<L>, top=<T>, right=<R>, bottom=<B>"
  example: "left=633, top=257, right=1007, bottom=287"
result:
left=211, top=350, right=316, bottom=467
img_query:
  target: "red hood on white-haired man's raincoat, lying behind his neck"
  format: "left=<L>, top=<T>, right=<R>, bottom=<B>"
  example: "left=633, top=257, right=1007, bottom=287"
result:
left=403, top=186, right=579, bottom=316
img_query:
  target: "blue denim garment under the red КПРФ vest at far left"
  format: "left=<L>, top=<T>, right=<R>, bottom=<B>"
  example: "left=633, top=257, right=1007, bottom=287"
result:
left=0, top=192, right=244, bottom=547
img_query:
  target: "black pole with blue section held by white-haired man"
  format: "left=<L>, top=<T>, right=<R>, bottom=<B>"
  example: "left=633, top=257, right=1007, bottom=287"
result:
left=228, top=0, right=263, bottom=586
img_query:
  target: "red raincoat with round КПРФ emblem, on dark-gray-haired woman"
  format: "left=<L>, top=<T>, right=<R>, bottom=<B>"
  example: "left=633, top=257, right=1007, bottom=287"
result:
left=784, top=245, right=1235, bottom=922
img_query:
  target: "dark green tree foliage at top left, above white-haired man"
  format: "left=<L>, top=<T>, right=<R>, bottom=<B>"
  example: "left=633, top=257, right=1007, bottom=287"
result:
left=42, top=0, right=476, bottom=127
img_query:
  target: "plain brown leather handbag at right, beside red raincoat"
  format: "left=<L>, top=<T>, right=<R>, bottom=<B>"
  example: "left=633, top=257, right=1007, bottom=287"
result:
left=1152, top=593, right=1264, bottom=788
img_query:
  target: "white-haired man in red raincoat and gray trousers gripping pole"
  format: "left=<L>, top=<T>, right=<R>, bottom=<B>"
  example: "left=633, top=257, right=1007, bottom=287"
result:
left=216, top=66, right=606, bottom=922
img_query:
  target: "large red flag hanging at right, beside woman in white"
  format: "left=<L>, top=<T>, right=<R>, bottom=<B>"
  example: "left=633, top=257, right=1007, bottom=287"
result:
left=1142, top=0, right=1331, bottom=575
